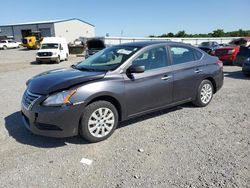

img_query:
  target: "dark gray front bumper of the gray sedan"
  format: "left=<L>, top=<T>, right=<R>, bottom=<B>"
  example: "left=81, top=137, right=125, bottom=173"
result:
left=21, top=101, right=83, bottom=138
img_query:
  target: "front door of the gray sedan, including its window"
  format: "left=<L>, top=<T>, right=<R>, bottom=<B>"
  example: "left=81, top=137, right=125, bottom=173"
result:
left=124, top=46, right=173, bottom=117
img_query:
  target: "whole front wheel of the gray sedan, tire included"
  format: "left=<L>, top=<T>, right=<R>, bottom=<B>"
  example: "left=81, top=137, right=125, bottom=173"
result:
left=79, top=101, right=118, bottom=143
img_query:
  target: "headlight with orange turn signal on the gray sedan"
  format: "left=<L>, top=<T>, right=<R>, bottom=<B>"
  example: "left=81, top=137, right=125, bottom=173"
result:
left=42, top=89, right=76, bottom=106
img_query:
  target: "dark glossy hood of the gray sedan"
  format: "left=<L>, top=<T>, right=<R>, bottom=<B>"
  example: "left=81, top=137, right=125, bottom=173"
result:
left=27, top=68, right=106, bottom=95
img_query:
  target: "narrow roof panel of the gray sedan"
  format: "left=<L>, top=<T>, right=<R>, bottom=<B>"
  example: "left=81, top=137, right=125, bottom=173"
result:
left=118, top=40, right=189, bottom=48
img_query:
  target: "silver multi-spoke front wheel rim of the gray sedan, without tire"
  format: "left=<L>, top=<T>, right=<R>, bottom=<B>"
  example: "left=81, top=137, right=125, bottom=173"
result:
left=88, top=108, right=115, bottom=138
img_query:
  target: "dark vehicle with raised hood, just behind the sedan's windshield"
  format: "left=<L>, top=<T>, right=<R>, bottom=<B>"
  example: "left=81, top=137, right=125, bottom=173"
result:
left=85, top=38, right=106, bottom=58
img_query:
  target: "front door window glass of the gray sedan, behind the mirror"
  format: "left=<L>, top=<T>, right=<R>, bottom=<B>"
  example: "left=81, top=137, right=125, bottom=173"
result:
left=132, top=47, right=167, bottom=71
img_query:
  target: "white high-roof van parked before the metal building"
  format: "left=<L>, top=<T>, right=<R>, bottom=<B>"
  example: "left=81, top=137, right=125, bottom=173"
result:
left=36, top=37, right=69, bottom=63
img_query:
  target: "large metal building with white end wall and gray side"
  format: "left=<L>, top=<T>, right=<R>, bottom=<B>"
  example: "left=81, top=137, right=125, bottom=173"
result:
left=0, top=18, right=95, bottom=42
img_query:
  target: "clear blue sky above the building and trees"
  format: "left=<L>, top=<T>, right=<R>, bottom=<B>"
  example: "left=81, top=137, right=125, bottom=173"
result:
left=0, top=0, right=250, bottom=37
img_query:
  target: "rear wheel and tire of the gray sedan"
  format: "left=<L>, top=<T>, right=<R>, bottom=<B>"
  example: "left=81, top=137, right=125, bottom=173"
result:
left=193, top=80, right=214, bottom=107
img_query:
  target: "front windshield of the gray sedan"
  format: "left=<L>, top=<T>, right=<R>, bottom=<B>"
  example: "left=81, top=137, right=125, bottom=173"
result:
left=75, top=46, right=139, bottom=71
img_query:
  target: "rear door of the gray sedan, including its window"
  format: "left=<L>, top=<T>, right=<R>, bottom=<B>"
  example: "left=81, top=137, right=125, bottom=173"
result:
left=169, top=45, right=204, bottom=102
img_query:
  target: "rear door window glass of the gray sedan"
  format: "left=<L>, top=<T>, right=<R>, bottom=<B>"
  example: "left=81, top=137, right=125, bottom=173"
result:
left=170, top=46, right=197, bottom=65
